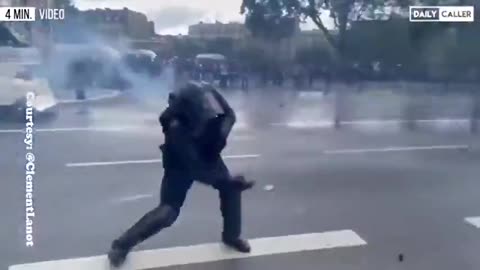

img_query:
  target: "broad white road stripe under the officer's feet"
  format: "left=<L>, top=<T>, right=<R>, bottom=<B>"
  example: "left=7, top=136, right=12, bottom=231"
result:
left=9, top=230, right=367, bottom=270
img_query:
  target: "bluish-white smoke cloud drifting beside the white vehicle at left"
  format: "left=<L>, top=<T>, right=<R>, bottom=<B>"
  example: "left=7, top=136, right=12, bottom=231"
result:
left=42, top=18, right=174, bottom=111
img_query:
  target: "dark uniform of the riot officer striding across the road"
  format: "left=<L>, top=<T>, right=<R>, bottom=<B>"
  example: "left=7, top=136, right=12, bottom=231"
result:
left=109, top=83, right=250, bottom=266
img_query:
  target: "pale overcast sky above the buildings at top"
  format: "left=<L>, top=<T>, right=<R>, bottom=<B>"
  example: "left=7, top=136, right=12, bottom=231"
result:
left=73, top=0, right=322, bottom=34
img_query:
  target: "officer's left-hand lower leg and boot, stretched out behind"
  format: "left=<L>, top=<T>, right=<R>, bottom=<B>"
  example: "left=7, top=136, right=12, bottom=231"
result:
left=108, top=204, right=179, bottom=267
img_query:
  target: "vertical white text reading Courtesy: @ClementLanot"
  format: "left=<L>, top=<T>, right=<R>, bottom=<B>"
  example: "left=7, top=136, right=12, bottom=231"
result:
left=24, top=92, right=35, bottom=247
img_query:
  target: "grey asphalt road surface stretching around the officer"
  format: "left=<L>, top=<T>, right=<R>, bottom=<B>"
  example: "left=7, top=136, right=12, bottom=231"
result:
left=0, top=89, right=480, bottom=270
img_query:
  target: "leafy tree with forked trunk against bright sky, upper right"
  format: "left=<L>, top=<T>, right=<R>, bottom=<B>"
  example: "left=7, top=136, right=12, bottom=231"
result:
left=241, top=0, right=462, bottom=70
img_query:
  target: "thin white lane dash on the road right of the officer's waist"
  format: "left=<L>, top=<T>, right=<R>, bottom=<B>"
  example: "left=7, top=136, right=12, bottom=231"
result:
left=323, top=145, right=469, bottom=155
